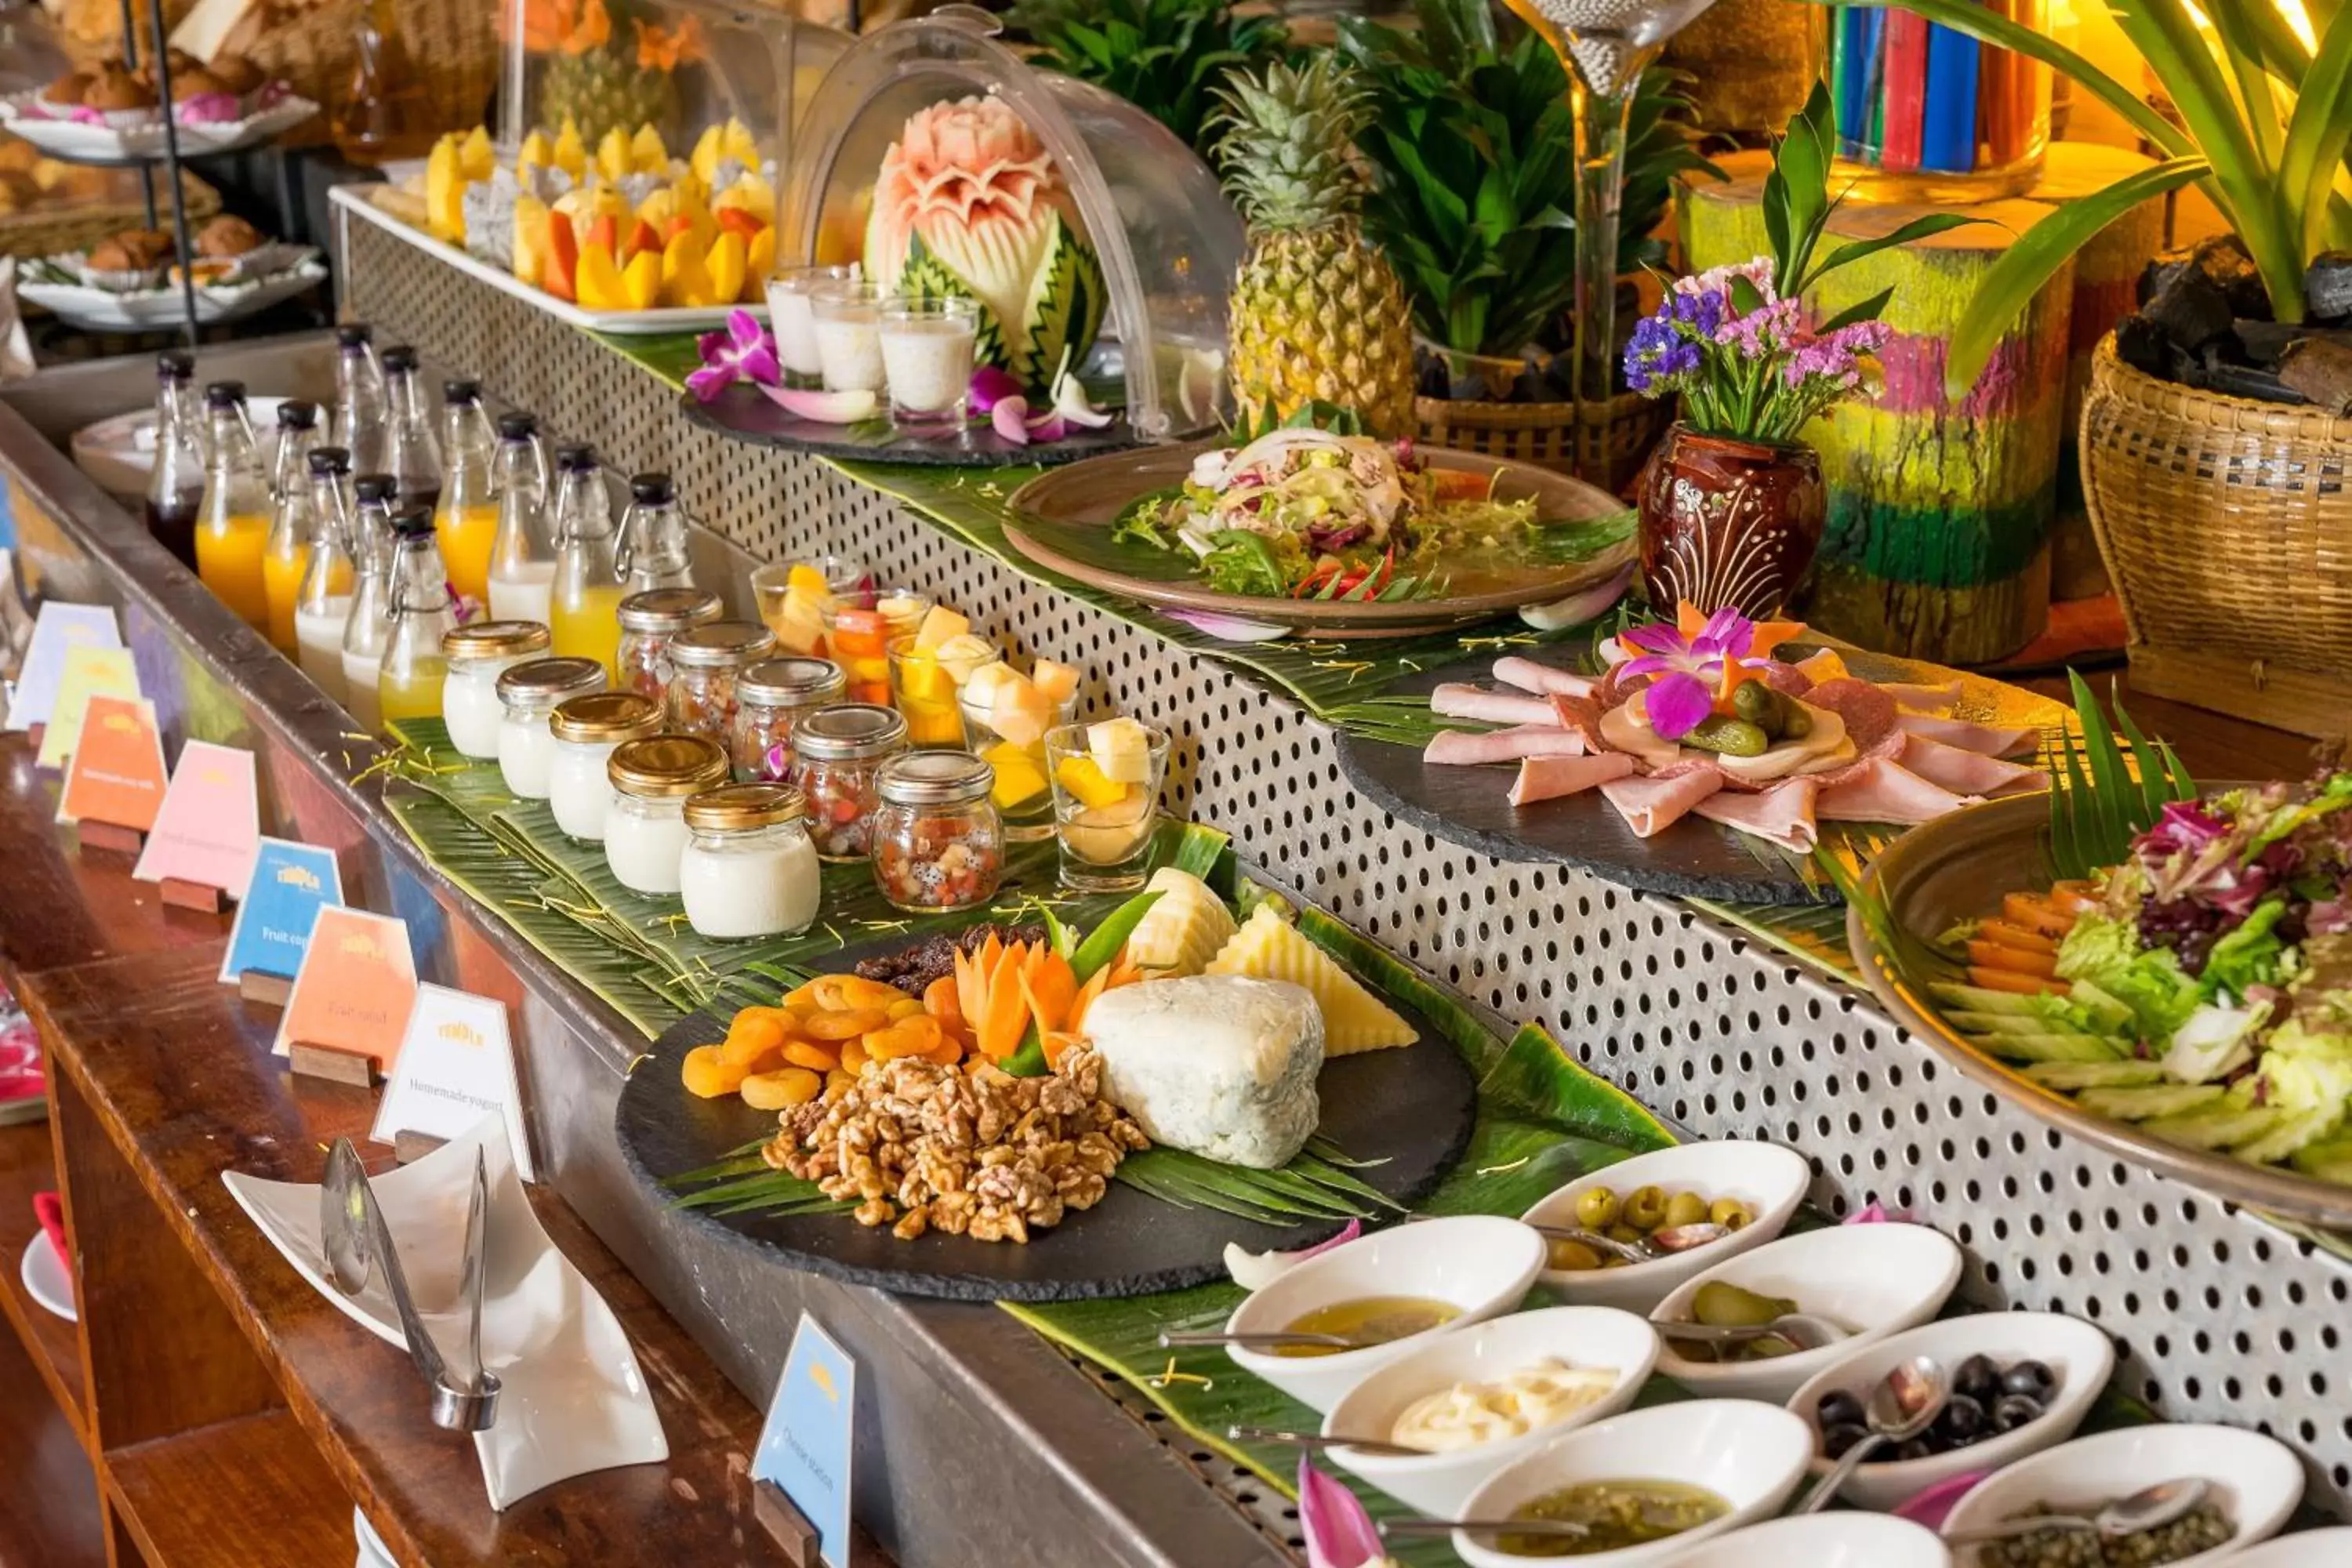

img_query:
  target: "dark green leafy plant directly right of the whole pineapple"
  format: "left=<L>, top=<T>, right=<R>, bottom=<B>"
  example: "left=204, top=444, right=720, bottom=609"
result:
left=1338, top=0, right=1722, bottom=355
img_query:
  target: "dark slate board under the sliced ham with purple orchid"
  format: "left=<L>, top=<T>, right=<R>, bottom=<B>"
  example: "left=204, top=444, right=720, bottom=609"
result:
left=1338, top=642, right=2065, bottom=905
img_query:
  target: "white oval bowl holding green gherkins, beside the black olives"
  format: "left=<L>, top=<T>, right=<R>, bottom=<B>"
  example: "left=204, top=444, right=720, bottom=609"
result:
left=1649, top=1225, right=1962, bottom=1403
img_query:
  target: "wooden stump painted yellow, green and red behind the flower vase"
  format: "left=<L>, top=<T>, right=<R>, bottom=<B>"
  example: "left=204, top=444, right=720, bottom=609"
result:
left=1679, top=153, right=2107, bottom=663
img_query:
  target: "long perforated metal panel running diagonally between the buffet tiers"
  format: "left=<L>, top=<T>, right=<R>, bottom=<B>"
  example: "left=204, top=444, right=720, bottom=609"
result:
left=346, top=223, right=2352, bottom=1535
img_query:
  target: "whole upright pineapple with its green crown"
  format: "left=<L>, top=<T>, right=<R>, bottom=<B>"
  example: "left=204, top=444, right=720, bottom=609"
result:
left=1211, top=54, right=1414, bottom=435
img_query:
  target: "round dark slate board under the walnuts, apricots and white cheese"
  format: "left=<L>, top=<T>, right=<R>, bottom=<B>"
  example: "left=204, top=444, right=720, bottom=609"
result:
left=614, top=938, right=1477, bottom=1302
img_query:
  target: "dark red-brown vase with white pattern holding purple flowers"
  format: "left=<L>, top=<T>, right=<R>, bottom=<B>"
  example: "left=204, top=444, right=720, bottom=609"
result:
left=1637, top=423, right=1830, bottom=619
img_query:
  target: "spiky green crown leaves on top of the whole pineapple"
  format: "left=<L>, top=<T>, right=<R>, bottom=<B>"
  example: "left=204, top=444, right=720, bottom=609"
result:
left=1207, top=54, right=1376, bottom=230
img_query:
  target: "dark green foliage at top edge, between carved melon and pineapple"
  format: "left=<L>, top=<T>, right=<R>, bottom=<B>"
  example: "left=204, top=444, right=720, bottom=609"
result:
left=1004, top=0, right=1289, bottom=155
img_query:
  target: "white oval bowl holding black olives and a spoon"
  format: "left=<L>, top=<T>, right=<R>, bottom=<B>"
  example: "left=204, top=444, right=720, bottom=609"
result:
left=1788, top=1312, right=2131, bottom=1512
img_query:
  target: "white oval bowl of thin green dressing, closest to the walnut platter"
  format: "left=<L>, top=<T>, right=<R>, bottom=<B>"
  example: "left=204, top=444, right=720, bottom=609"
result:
left=1225, top=1215, right=1543, bottom=1410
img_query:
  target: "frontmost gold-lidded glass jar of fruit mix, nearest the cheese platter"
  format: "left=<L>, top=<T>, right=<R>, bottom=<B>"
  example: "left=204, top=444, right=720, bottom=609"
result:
left=873, top=753, right=1004, bottom=914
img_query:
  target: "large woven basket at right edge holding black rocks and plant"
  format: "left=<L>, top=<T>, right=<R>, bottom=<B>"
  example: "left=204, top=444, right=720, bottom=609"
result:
left=2082, top=334, right=2352, bottom=736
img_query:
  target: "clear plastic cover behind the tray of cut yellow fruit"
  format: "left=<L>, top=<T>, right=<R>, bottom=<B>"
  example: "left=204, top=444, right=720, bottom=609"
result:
left=499, top=0, right=851, bottom=169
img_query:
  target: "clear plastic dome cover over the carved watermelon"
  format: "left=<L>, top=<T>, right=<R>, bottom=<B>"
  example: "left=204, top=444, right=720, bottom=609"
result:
left=776, top=5, right=1242, bottom=440
